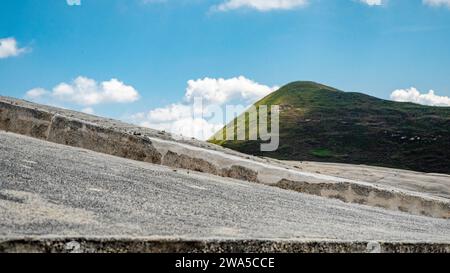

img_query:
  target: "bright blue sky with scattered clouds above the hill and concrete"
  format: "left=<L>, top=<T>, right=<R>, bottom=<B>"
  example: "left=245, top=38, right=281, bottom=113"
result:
left=0, top=0, right=450, bottom=138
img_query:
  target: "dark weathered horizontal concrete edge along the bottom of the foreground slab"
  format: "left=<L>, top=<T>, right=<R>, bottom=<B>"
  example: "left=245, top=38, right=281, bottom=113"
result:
left=0, top=237, right=450, bottom=253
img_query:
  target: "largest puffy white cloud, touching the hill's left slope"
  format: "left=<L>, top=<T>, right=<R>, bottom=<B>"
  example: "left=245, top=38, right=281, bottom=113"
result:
left=130, top=76, right=278, bottom=140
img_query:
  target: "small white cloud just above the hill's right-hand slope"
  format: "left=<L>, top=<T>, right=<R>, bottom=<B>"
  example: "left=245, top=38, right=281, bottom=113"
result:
left=391, top=87, right=450, bottom=106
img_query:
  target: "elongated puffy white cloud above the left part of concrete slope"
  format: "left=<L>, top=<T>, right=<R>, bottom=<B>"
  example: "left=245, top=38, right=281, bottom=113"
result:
left=25, top=76, right=139, bottom=109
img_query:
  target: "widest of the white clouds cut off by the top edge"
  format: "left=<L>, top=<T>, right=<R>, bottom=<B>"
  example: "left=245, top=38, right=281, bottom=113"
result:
left=213, top=0, right=308, bottom=11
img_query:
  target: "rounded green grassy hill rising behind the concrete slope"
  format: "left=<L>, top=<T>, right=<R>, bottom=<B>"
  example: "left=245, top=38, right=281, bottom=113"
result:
left=210, top=82, right=450, bottom=174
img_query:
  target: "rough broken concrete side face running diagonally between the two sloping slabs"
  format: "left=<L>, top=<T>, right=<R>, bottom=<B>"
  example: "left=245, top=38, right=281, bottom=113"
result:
left=0, top=96, right=450, bottom=219
